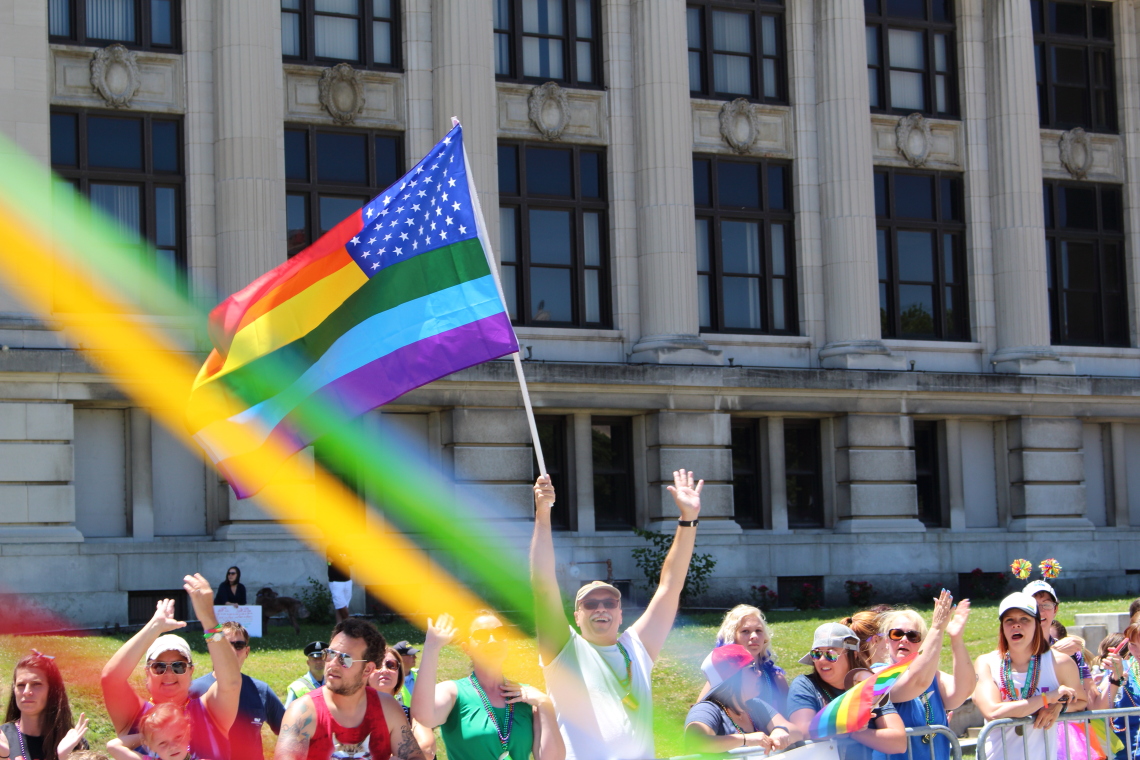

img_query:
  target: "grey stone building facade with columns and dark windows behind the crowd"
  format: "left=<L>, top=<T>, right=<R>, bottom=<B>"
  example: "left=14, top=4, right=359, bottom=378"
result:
left=0, top=0, right=1140, bottom=624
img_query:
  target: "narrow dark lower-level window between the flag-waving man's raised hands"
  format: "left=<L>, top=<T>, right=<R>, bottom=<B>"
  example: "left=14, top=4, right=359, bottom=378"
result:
left=591, top=417, right=635, bottom=531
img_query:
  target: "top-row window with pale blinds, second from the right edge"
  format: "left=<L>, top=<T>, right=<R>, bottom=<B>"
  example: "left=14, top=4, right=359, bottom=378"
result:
left=863, top=0, right=958, bottom=119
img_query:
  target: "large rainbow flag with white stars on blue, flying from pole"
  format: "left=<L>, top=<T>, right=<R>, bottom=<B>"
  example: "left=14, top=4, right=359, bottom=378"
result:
left=188, top=124, right=519, bottom=498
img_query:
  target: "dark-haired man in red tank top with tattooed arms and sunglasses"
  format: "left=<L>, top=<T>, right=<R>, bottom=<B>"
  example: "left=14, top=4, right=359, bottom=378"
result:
left=274, top=618, right=424, bottom=760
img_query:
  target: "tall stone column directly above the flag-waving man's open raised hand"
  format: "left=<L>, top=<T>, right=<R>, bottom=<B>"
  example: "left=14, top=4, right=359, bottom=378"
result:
left=633, top=0, right=723, bottom=365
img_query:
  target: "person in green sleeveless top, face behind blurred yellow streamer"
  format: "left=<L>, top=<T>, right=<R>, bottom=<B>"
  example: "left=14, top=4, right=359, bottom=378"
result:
left=412, top=612, right=565, bottom=760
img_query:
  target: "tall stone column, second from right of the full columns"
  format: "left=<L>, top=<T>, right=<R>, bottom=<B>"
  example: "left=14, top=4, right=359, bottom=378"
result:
left=815, top=0, right=905, bottom=369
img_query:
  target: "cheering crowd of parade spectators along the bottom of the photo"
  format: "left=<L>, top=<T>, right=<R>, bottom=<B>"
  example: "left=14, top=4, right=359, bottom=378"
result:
left=0, top=471, right=1140, bottom=760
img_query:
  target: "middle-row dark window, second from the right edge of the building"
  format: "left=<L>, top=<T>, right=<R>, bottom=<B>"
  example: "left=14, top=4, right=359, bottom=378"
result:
left=874, top=170, right=969, bottom=341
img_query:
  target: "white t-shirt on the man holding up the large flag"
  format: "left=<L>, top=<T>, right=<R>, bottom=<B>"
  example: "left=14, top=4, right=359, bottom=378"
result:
left=543, top=628, right=653, bottom=760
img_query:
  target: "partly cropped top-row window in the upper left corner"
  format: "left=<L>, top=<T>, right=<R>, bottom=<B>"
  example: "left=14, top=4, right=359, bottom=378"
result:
left=48, top=0, right=176, bottom=52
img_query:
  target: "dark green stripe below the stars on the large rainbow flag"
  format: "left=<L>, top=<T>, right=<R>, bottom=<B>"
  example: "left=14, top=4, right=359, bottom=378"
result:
left=220, top=238, right=490, bottom=407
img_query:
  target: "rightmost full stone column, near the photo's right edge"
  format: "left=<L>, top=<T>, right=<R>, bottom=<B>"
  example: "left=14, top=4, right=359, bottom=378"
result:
left=984, top=0, right=1074, bottom=375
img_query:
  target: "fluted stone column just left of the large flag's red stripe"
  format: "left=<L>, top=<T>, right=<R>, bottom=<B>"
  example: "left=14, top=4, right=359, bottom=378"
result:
left=213, top=0, right=285, bottom=297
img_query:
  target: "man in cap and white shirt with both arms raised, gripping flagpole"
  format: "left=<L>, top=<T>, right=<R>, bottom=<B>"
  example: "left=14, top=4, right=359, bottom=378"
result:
left=530, top=469, right=705, bottom=760
